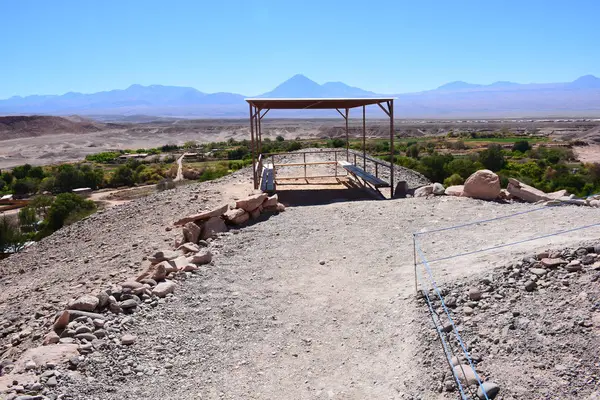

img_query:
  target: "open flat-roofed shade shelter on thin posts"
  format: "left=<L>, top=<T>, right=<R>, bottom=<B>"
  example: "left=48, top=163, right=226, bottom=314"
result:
left=246, top=97, right=395, bottom=198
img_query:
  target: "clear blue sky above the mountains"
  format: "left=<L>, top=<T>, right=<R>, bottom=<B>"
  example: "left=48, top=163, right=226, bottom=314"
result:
left=0, top=0, right=600, bottom=98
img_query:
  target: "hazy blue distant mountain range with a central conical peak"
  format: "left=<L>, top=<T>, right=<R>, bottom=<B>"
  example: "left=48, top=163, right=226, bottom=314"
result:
left=0, top=75, right=600, bottom=118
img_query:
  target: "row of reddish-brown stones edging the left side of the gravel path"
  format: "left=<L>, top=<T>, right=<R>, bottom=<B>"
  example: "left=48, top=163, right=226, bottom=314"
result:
left=0, top=193, right=285, bottom=400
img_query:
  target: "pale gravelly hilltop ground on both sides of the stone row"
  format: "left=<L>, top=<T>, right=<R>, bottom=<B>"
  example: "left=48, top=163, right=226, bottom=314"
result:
left=0, top=164, right=600, bottom=400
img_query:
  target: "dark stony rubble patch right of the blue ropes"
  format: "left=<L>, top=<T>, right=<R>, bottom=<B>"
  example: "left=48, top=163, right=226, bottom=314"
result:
left=421, top=246, right=600, bottom=399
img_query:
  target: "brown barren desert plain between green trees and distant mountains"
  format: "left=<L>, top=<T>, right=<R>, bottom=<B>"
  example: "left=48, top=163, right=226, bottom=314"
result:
left=0, top=118, right=599, bottom=169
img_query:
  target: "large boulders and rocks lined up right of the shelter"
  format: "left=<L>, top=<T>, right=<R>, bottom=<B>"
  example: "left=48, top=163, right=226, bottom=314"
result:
left=414, top=169, right=600, bottom=207
